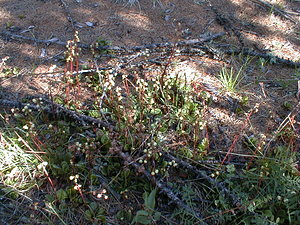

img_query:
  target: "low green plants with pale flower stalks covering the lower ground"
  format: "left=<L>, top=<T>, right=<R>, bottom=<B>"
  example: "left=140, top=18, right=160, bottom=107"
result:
left=0, top=32, right=300, bottom=225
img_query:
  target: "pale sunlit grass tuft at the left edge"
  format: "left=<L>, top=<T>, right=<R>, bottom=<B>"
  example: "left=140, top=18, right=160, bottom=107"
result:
left=0, top=114, right=44, bottom=224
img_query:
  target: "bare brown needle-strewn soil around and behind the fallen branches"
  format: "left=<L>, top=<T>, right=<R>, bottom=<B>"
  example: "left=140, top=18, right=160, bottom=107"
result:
left=0, top=0, right=300, bottom=132
